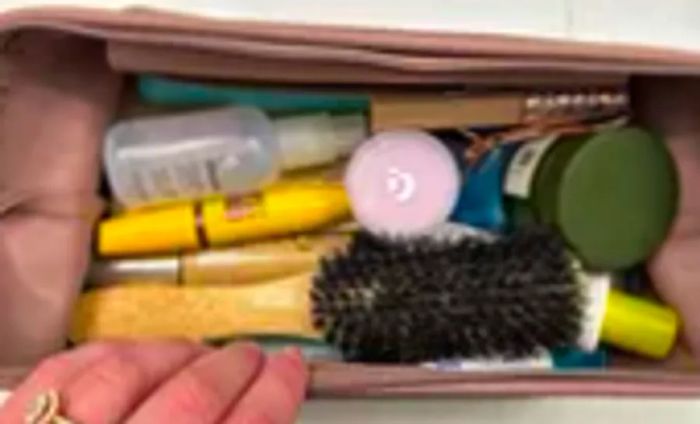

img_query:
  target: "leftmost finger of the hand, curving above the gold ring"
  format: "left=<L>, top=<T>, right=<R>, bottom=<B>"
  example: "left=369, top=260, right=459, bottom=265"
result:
left=0, top=343, right=119, bottom=423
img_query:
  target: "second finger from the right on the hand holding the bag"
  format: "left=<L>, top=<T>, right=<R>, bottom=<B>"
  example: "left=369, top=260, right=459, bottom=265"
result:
left=128, top=343, right=264, bottom=424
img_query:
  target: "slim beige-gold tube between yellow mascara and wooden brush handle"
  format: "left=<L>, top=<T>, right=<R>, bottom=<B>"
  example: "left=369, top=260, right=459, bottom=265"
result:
left=87, top=232, right=350, bottom=287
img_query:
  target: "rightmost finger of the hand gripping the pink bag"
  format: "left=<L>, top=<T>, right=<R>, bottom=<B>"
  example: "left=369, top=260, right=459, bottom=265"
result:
left=226, top=349, right=308, bottom=424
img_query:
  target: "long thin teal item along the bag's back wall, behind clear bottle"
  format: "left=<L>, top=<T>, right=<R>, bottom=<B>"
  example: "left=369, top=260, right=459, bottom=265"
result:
left=138, top=75, right=369, bottom=113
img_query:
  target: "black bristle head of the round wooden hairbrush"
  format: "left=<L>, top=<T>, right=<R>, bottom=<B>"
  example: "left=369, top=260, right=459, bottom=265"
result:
left=312, top=225, right=584, bottom=362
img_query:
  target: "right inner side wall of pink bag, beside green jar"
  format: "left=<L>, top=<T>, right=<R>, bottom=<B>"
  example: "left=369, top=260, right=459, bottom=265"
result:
left=634, top=78, right=700, bottom=361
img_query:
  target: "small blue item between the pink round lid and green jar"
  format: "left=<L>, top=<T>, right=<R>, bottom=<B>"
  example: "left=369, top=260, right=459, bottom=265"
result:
left=452, top=147, right=510, bottom=232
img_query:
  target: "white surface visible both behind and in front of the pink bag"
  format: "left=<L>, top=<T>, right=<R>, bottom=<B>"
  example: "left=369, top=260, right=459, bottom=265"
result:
left=0, top=0, right=700, bottom=424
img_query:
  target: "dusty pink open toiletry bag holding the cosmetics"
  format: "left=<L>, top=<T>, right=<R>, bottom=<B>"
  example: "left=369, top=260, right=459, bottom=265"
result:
left=0, top=8, right=700, bottom=397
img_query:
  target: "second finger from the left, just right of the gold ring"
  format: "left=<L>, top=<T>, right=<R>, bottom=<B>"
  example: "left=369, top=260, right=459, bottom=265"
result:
left=60, top=342, right=208, bottom=424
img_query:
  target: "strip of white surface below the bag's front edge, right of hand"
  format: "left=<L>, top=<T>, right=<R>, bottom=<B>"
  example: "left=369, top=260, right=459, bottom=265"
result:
left=299, top=398, right=700, bottom=424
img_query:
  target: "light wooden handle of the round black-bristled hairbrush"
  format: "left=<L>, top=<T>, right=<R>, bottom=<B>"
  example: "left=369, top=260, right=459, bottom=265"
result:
left=70, top=274, right=320, bottom=342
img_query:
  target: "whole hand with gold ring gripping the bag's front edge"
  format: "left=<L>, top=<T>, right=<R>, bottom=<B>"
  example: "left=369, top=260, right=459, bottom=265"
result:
left=0, top=342, right=308, bottom=424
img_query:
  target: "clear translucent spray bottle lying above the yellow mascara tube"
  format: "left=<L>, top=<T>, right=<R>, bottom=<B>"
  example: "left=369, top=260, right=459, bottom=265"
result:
left=104, top=107, right=365, bottom=207
